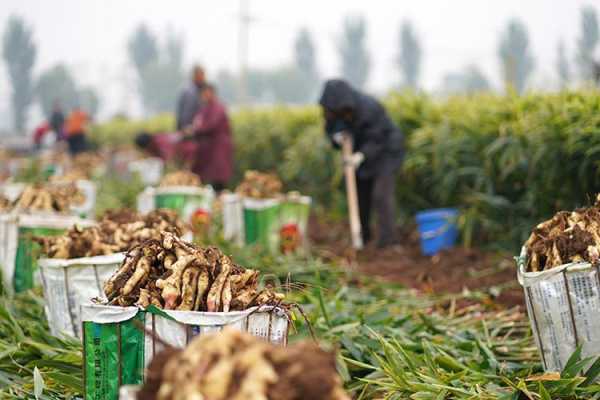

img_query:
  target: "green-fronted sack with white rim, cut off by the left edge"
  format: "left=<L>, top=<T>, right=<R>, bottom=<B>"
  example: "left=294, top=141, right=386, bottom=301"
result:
left=0, top=213, right=94, bottom=292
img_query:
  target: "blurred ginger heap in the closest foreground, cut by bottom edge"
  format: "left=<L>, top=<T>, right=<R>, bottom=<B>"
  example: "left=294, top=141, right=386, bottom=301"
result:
left=138, top=329, right=350, bottom=400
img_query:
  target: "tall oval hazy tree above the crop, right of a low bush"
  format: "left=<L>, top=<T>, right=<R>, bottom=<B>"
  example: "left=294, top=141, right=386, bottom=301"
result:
left=498, top=19, right=534, bottom=94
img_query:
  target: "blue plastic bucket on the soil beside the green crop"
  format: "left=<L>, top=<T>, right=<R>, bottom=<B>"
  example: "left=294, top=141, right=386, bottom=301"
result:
left=416, top=208, right=458, bottom=256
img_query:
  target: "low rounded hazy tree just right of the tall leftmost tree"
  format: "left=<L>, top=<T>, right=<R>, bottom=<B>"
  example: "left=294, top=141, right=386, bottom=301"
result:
left=35, top=64, right=79, bottom=117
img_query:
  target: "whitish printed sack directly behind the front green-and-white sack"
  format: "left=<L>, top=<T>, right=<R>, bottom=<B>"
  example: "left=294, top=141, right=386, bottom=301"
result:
left=38, top=253, right=125, bottom=338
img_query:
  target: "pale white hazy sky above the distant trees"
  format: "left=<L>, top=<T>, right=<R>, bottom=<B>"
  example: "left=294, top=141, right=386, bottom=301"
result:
left=0, top=0, right=600, bottom=123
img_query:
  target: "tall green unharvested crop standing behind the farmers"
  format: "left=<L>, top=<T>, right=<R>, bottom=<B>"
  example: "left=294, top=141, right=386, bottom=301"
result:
left=92, top=90, right=600, bottom=252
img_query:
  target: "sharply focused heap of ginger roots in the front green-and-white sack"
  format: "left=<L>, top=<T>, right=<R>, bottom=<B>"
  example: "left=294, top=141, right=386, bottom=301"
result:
left=104, top=232, right=284, bottom=312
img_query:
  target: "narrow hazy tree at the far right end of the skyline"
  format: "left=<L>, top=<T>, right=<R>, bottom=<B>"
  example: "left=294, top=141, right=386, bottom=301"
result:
left=575, top=6, right=600, bottom=80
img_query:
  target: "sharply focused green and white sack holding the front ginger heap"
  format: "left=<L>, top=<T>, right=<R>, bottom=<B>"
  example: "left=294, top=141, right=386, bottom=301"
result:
left=81, top=304, right=289, bottom=400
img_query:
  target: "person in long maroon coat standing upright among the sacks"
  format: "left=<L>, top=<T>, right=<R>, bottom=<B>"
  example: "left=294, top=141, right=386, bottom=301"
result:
left=185, top=84, right=233, bottom=191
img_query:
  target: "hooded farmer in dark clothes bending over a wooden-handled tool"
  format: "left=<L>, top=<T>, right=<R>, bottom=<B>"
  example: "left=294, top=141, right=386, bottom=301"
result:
left=319, top=79, right=404, bottom=247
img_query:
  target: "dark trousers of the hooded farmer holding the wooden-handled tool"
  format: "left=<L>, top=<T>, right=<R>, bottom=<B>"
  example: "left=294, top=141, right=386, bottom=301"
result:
left=356, top=171, right=396, bottom=246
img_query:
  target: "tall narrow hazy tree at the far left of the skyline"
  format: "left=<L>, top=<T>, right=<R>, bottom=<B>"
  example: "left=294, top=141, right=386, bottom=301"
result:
left=2, top=16, right=36, bottom=132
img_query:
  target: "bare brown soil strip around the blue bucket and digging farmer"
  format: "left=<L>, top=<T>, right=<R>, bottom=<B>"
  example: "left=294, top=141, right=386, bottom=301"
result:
left=310, top=218, right=525, bottom=307
